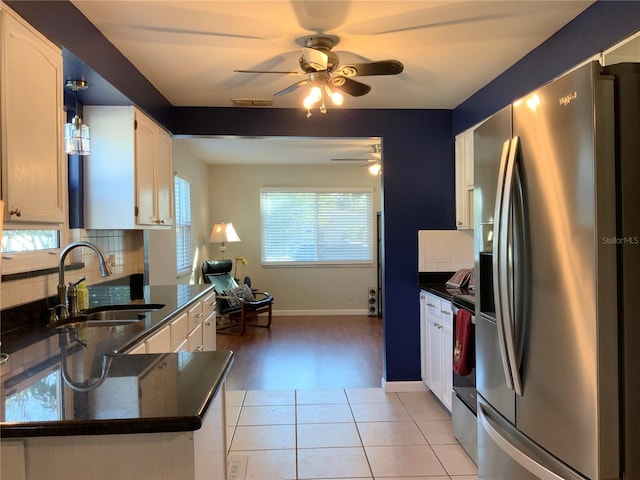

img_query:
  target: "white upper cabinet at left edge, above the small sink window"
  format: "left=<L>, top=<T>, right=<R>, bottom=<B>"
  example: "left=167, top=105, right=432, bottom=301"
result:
left=0, top=3, right=66, bottom=224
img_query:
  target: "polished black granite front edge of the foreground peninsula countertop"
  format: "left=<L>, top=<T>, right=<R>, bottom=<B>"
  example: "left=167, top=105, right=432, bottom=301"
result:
left=0, top=350, right=233, bottom=438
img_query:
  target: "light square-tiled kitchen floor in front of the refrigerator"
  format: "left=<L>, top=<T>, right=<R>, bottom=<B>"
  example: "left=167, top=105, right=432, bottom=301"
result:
left=226, top=388, right=477, bottom=480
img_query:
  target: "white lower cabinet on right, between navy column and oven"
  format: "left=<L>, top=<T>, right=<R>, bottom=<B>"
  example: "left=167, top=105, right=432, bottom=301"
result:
left=420, top=291, right=453, bottom=411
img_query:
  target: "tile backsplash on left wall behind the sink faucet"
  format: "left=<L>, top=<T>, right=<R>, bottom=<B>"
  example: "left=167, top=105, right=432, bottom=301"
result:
left=0, top=229, right=144, bottom=309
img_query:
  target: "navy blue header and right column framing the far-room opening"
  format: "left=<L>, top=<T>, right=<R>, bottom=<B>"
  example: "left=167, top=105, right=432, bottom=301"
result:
left=174, top=107, right=455, bottom=381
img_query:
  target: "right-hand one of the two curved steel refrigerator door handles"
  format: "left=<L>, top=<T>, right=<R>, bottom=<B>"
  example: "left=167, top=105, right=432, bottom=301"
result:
left=499, top=137, right=522, bottom=395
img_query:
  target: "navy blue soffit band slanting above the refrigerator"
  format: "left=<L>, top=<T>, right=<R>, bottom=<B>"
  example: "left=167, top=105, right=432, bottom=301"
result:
left=453, top=1, right=640, bottom=134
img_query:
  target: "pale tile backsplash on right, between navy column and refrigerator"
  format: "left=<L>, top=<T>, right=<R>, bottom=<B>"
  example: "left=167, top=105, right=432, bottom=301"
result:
left=418, top=230, right=473, bottom=272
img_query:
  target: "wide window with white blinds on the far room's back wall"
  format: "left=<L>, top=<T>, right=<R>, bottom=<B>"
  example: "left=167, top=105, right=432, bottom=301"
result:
left=260, top=188, right=373, bottom=265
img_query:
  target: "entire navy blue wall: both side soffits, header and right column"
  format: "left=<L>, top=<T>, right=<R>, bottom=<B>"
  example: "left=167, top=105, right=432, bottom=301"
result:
left=7, top=0, right=640, bottom=381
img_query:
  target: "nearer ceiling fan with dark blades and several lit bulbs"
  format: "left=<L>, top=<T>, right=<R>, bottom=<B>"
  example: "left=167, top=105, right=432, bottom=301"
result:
left=234, top=35, right=404, bottom=117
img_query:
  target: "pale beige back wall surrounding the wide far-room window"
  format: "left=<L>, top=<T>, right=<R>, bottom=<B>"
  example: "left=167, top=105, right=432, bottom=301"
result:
left=209, top=165, right=381, bottom=315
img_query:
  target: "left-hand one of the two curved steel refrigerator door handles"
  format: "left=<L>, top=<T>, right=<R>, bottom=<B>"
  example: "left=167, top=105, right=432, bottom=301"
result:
left=492, top=140, right=514, bottom=390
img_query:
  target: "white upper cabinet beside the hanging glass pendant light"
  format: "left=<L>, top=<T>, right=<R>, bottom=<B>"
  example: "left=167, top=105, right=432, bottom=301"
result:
left=84, top=106, right=173, bottom=229
